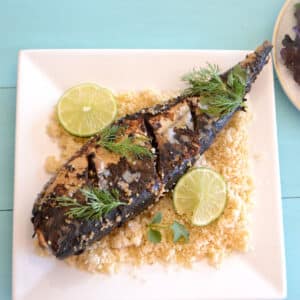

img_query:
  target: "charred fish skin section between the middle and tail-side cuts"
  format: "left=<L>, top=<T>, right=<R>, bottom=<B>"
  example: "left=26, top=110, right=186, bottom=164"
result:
left=147, top=100, right=200, bottom=190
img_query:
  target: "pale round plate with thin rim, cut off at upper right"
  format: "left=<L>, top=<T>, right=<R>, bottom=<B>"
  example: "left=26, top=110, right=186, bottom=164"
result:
left=273, top=0, right=300, bottom=110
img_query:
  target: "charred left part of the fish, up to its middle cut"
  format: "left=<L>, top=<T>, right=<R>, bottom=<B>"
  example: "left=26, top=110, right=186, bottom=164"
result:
left=32, top=118, right=162, bottom=258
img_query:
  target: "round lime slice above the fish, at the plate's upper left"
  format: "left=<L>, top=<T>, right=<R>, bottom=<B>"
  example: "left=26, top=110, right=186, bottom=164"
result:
left=57, top=83, right=117, bottom=137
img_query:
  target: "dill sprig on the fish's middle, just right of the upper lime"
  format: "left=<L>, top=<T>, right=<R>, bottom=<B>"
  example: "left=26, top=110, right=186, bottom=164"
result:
left=98, top=125, right=153, bottom=159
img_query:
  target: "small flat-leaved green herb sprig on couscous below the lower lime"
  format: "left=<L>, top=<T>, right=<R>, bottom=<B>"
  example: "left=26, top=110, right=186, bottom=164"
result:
left=147, top=212, right=189, bottom=244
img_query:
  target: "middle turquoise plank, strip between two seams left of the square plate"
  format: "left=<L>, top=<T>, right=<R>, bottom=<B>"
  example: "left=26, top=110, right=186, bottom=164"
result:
left=0, top=89, right=16, bottom=211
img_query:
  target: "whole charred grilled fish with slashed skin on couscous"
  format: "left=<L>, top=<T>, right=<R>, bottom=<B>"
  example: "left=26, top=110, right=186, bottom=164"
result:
left=32, top=42, right=272, bottom=259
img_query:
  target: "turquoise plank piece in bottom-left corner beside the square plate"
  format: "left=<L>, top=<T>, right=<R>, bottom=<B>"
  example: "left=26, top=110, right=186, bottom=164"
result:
left=0, top=211, right=12, bottom=300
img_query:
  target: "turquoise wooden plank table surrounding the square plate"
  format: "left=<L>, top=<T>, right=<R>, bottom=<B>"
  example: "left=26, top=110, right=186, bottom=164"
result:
left=0, top=0, right=300, bottom=300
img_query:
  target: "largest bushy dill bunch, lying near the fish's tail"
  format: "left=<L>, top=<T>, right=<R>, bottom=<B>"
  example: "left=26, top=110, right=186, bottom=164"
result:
left=182, top=64, right=247, bottom=117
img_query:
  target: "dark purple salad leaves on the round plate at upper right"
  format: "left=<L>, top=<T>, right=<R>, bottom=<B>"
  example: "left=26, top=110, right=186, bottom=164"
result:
left=280, top=3, right=300, bottom=84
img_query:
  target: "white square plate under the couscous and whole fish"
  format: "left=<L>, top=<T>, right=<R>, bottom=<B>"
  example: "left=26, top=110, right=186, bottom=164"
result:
left=13, top=50, right=286, bottom=300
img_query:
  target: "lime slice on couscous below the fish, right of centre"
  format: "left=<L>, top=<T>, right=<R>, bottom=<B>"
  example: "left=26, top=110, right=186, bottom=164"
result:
left=173, top=168, right=227, bottom=226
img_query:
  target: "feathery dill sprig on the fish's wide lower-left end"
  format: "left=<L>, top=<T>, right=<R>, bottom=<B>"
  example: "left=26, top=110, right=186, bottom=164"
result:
left=56, top=188, right=126, bottom=220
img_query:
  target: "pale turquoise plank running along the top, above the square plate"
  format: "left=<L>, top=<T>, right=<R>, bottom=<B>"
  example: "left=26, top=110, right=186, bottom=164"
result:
left=0, top=0, right=284, bottom=86
